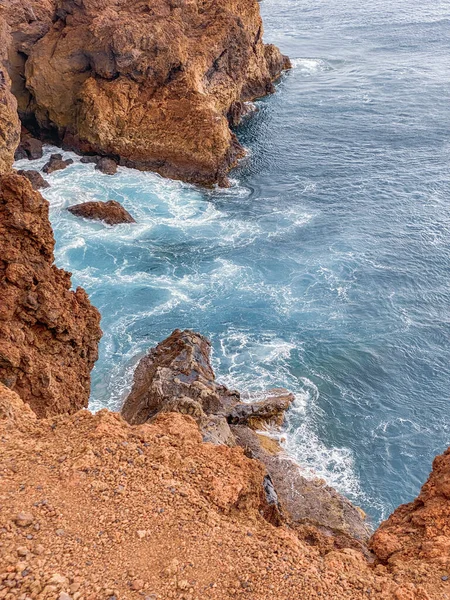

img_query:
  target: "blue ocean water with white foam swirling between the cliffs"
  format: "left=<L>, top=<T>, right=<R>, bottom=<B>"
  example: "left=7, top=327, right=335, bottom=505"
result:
left=13, top=0, right=450, bottom=523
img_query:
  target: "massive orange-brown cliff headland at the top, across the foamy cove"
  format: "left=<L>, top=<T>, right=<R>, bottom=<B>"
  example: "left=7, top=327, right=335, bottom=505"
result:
left=19, top=0, right=289, bottom=184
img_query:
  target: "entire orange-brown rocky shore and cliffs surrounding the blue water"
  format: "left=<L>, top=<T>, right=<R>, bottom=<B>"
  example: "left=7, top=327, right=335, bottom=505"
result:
left=0, top=0, right=450, bottom=600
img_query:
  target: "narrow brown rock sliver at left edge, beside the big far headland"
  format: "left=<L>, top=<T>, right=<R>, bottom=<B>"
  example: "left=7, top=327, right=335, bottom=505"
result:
left=0, top=21, right=20, bottom=175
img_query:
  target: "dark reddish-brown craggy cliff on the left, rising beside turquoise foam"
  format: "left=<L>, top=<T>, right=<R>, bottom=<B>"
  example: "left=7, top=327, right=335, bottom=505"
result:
left=0, top=174, right=101, bottom=417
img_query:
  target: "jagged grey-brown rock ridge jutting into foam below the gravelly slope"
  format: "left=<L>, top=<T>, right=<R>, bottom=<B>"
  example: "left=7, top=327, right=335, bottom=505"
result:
left=122, top=330, right=370, bottom=547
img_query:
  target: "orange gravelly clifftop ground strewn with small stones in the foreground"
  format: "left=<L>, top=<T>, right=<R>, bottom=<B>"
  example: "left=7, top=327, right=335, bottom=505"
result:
left=0, top=384, right=449, bottom=600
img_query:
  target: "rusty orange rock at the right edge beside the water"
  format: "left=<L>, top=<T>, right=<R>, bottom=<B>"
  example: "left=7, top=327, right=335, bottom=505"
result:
left=370, top=448, right=450, bottom=569
